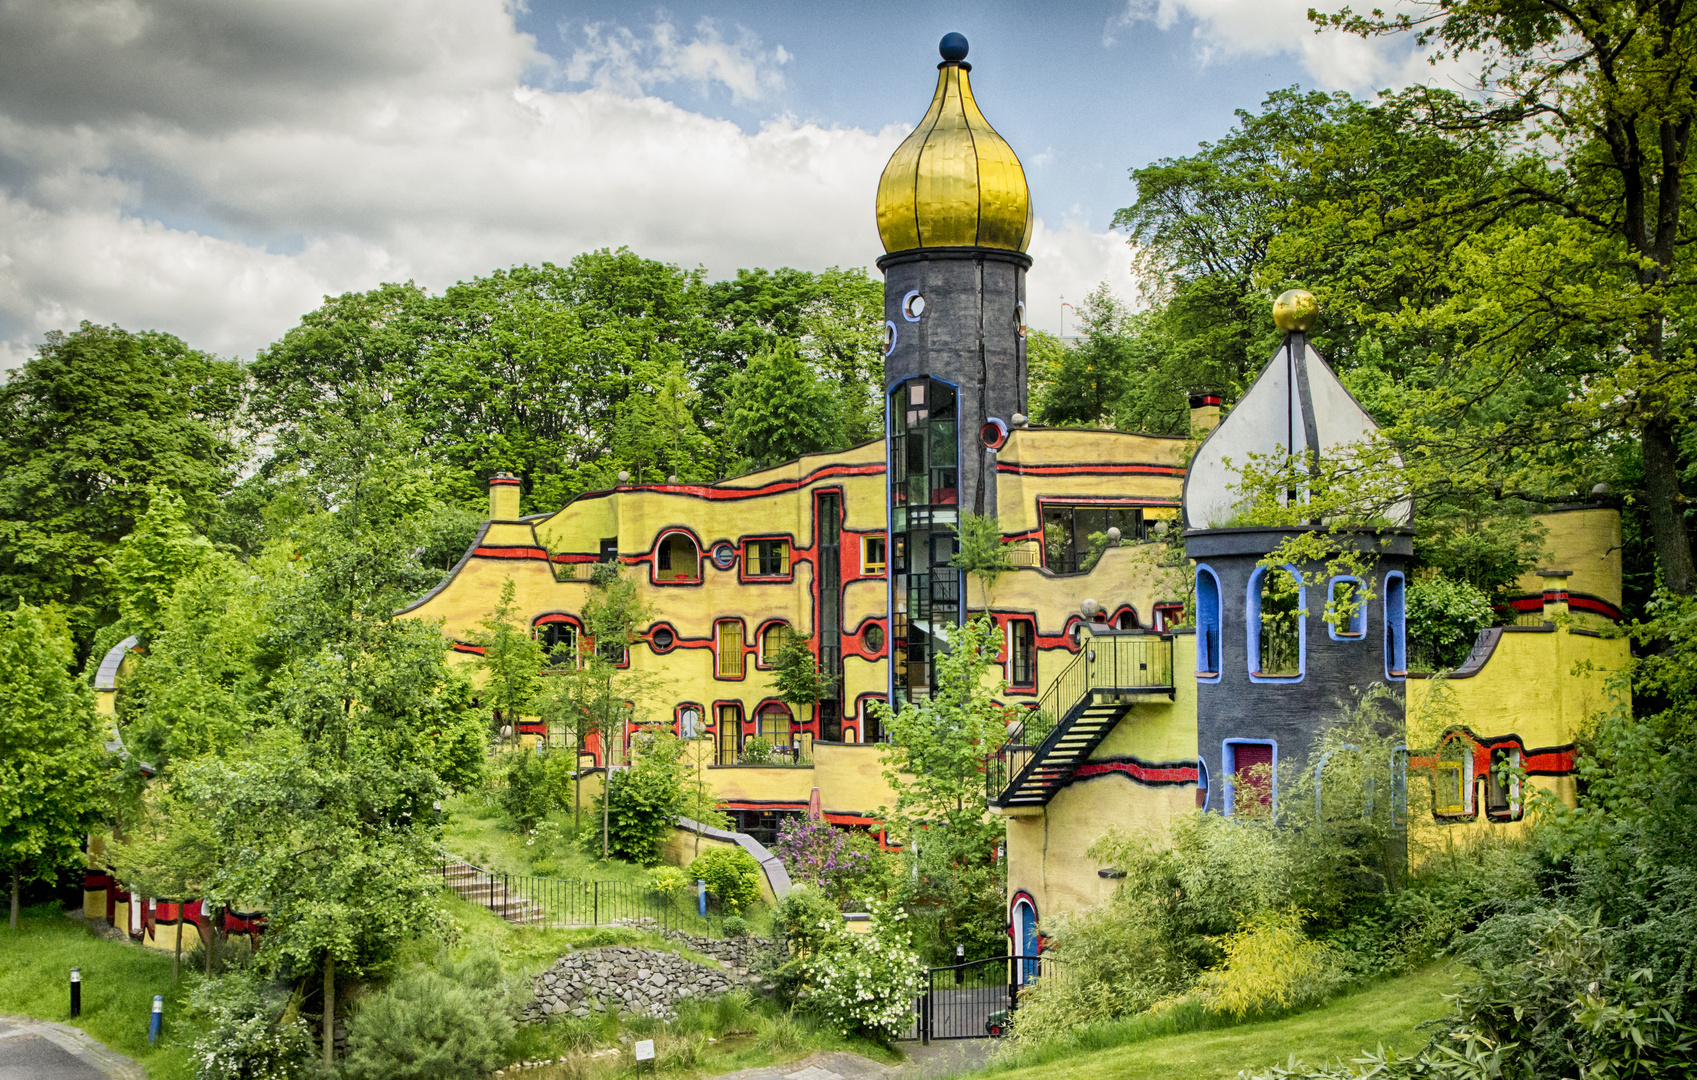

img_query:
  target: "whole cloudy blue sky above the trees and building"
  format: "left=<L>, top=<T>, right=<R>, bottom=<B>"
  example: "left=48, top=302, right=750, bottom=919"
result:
left=0, top=0, right=1427, bottom=367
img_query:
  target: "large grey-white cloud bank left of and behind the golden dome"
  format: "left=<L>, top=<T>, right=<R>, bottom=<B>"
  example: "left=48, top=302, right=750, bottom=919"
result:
left=0, top=0, right=1129, bottom=367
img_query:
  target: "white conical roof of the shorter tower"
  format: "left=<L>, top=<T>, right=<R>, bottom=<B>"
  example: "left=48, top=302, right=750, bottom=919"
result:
left=1185, top=335, right=1412, bottom=528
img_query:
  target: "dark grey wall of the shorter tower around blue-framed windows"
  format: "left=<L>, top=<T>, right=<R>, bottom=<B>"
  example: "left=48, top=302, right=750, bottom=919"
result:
left=1185, top=528, right=1414, bottom=812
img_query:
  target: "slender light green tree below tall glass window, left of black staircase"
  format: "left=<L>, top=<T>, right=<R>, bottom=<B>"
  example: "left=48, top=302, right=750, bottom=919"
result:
left=874, top=616, right=1010, bottom=956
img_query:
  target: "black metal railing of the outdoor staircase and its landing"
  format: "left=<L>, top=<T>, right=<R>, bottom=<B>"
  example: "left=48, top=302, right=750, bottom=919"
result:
left=984, top=632, right=1174, bottom=803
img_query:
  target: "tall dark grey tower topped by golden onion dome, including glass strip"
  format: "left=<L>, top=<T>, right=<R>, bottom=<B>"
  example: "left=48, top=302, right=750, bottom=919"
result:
left=877, top=34, right=1032, bottom=701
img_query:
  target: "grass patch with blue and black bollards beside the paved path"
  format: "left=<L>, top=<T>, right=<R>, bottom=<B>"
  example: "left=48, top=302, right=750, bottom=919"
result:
left=0, top=903, right=199, bottom=1080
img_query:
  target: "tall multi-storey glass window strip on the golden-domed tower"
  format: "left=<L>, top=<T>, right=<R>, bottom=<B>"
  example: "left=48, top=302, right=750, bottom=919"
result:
left=889, top=379, right=961, bottom=701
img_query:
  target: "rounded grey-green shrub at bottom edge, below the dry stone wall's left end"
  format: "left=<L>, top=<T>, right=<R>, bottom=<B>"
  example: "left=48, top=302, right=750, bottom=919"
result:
left=343, top=954, right=514, bottom=1080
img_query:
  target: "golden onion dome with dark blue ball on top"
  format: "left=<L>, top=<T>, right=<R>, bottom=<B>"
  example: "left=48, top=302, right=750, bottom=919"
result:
left=877, top=34, right=1032, bottom=251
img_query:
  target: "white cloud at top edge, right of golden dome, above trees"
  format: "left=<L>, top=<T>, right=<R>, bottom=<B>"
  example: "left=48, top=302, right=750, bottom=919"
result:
left=1103, top=0, right=1471, bottom=93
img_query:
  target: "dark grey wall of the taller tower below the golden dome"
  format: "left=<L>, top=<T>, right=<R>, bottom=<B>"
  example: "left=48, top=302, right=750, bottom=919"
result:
left=879, top=248, right=1032, bottom=515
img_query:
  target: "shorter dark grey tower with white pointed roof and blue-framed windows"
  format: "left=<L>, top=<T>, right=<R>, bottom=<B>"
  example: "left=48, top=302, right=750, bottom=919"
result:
left=1185, top=294, right=1414, bottom=813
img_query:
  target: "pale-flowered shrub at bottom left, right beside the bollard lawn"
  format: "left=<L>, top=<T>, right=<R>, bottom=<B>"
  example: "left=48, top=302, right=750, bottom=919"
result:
left=190, top=971, right=314, bottom=1080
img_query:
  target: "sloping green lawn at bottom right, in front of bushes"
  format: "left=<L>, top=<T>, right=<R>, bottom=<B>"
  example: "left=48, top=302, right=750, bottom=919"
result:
left=986, top=968, right=1453, bottom=1080
